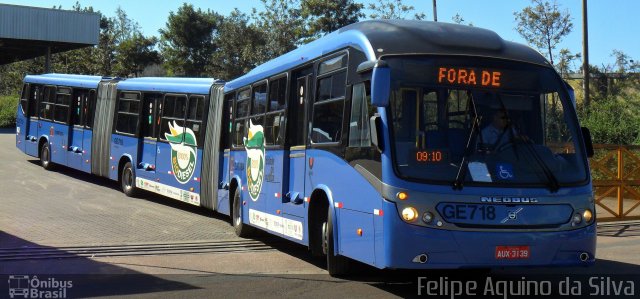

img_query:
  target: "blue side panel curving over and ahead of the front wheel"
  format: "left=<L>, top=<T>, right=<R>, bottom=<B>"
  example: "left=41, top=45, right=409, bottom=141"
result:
left=306, top=149, right=382, bottom=266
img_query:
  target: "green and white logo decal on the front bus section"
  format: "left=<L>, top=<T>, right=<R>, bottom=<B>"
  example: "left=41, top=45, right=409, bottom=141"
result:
left=244, top=120, right=265, bottom=201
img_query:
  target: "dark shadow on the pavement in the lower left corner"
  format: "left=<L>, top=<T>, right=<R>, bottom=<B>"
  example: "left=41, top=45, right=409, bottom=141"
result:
left=0, top=231, right=198, bottom=298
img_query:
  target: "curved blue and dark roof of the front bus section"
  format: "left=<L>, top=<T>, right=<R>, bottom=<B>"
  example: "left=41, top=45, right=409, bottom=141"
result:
left=225, top=20, right=549, bottom=91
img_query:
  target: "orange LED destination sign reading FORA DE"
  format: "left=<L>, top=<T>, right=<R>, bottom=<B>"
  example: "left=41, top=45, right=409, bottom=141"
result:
left=438, top=67, right=502, bottom=87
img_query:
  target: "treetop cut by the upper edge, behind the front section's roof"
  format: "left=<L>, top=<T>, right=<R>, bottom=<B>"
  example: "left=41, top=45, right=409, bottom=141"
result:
left=302, top=0, right=365, bottom=39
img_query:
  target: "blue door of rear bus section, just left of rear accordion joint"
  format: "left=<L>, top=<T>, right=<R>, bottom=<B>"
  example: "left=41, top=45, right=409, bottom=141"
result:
left=67, top=89, right=91, bottom=169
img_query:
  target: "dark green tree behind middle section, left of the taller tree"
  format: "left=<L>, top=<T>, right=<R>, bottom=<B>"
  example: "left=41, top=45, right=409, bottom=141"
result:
left=114, top=33, right=162, bottom=77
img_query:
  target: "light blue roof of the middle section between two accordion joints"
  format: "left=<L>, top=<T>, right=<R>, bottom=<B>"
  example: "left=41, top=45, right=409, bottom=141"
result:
left=118, top=77, right=221, bottom=94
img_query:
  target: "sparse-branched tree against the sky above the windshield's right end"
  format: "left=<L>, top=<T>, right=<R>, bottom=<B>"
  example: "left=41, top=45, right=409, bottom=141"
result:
left=514, top=0, right=573, bottom=65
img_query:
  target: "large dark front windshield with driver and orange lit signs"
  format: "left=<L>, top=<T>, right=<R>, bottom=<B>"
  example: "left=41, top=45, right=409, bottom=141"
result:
left=387, top=57, right=587, bottom=189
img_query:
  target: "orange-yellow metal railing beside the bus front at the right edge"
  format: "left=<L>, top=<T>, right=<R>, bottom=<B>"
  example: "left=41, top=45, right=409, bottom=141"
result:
left=589, top=144, right=640, bottom=221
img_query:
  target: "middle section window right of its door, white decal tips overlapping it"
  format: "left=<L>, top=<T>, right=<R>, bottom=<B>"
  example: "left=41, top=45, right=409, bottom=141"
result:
left=159, top=95, right=187, bottom=143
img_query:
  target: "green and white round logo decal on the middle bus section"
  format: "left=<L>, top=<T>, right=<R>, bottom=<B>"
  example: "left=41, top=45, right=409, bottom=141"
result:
left=164, top=120, right=198, bottom=184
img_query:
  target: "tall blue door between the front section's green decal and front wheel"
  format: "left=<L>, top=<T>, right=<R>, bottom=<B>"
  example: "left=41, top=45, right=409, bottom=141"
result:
left=282, top=69, right=311, bottom=217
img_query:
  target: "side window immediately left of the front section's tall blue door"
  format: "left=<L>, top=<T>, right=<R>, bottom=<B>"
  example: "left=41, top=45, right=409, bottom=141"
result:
left=264, top=77, right=287, bottom=145
